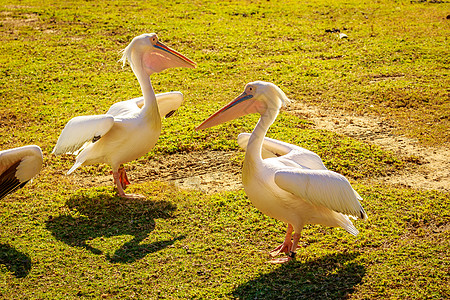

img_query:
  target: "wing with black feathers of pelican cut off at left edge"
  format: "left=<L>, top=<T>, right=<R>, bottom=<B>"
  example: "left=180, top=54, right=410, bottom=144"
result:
left=0, top=145, right=42, bottom=199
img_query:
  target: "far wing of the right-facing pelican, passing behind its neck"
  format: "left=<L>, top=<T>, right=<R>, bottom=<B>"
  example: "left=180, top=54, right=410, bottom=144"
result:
left=106, top=92, right=184, bottom=119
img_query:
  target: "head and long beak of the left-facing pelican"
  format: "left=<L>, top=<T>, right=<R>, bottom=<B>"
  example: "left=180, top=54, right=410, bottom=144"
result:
left=195, top=81, right=290, bottom=130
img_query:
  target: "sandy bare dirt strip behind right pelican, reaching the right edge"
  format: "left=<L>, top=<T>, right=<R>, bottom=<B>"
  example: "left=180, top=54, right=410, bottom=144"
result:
left=288, top=102, right=450, bottom=192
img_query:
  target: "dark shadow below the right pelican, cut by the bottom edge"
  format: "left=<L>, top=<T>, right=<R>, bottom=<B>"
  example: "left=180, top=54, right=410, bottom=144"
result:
left=232, top=253, right=366, bottom=299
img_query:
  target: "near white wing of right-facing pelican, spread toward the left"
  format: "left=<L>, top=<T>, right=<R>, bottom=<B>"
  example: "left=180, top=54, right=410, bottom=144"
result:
left=52, top=114, right=114, bottom=155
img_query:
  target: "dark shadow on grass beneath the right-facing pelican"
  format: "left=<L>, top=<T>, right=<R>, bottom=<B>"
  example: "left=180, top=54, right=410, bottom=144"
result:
left=46, top=194, right=184, bottom=263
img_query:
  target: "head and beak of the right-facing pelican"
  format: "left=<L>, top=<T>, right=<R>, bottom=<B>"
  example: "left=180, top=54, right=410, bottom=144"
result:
left=120, top=33, right=197, bottom=76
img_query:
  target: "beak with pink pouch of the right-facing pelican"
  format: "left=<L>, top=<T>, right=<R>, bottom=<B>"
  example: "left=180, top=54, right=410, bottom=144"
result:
left=143, top=41, right=197, bottom=73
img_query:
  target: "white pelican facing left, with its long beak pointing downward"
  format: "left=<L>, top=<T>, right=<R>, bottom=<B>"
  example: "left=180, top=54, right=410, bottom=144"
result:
left=196, top=81, right=367, bottom=263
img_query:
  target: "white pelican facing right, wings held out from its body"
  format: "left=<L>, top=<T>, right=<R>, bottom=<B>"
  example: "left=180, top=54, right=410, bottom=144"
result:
left=52, top=33, right=196, bottom=198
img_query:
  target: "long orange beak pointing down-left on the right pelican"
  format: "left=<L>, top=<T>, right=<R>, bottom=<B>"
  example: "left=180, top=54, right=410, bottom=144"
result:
left=195, top=92, right=264, bottom=130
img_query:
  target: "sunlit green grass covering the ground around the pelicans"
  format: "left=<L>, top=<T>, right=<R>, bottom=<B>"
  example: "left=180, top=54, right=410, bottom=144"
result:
left=0, top=0, right=450, bottom=299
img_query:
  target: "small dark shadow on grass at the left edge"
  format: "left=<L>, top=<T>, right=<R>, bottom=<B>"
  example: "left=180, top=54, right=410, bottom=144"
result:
left=0, top=244, right=31, bottom=278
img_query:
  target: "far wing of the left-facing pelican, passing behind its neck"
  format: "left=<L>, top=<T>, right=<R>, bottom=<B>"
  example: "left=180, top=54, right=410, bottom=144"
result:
left=237, top=133, right=327, bottom=170
